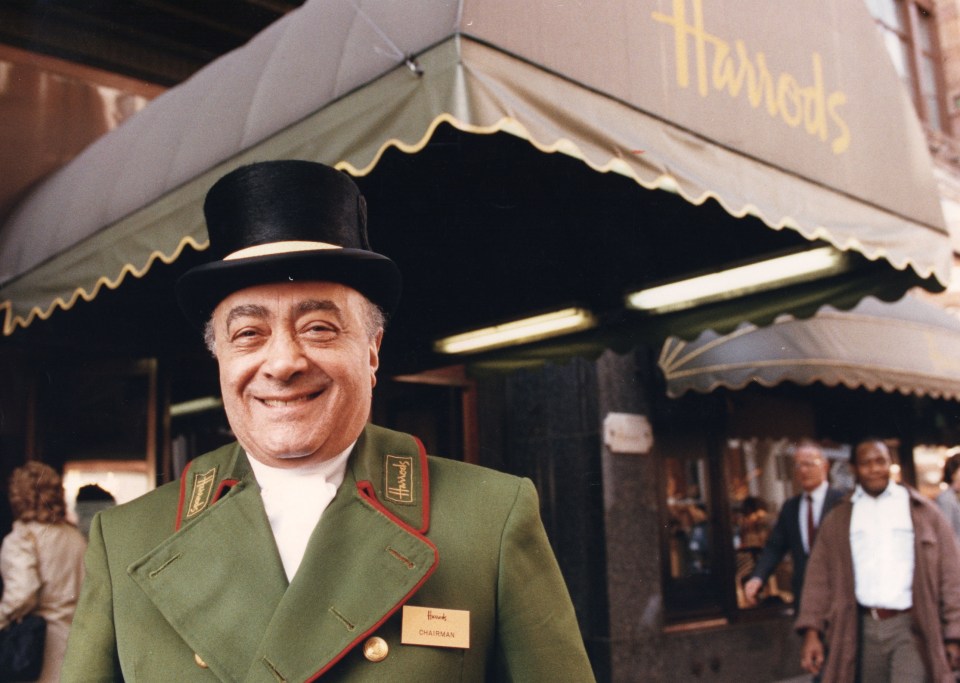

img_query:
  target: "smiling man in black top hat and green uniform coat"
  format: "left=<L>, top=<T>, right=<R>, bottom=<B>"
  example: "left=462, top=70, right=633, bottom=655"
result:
left=62, top=161, right=593, bottom=683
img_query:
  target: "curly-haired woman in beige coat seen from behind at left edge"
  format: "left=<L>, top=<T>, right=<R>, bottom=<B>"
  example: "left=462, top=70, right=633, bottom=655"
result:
left=0, top=462, right=87, bottom=683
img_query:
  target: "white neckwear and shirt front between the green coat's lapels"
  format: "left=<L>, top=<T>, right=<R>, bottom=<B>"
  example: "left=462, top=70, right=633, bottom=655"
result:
left=247, top=445, right=353, bottom=581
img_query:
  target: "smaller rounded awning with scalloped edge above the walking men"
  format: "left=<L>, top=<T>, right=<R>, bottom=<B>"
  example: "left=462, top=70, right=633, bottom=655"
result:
left=659, top=295, right=960, bottom=400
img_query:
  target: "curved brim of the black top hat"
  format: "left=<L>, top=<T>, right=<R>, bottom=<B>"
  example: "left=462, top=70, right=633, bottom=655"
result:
left=176, top=249, right=401, bottom=329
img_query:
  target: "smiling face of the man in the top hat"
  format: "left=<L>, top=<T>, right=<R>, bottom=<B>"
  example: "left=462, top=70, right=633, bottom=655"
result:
left=213, top=282, right=383, bottom=467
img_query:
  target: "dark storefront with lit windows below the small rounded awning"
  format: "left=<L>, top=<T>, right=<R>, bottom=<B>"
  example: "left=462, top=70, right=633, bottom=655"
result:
left=654, top=386, right=960, bottom=630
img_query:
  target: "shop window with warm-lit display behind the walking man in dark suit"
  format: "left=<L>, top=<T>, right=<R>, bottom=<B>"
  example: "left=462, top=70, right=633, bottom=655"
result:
left=660, top=436, right=853, bottom=622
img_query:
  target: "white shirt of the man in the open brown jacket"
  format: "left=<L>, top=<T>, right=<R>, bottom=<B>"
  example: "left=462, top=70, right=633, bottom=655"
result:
left=850, top=482, right=914, bottom=609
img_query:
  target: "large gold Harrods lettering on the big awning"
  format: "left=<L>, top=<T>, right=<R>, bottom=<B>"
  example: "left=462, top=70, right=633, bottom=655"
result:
left=653, top=0, right=851, bottom=154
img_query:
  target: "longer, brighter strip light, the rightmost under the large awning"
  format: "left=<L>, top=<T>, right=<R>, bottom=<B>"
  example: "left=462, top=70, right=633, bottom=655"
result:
left=627, top=247, right=849, bottom=313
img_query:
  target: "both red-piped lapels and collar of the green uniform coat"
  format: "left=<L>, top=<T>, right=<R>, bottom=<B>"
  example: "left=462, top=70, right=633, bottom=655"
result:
left=128, top=427, right=439, bottom=681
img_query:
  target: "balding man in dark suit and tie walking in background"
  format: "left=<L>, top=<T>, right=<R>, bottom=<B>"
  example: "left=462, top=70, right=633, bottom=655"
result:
left=743, top=440, right=843, bottom=606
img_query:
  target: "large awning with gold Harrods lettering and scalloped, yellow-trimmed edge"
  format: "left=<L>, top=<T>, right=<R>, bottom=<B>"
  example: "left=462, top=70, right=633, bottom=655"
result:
left=0, top=0, right=951, bottom=334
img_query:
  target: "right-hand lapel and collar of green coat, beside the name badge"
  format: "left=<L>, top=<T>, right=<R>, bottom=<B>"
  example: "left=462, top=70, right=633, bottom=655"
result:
left=245, top=428, right=439, bottom=681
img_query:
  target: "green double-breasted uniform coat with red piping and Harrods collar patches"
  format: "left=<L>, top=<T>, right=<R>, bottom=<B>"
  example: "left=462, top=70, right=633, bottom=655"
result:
left=61, top=426, right=593, bottom=683
